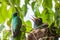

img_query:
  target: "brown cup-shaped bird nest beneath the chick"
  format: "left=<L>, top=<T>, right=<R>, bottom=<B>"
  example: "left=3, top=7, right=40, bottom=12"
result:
left=27, top=28, right=59, bottom=40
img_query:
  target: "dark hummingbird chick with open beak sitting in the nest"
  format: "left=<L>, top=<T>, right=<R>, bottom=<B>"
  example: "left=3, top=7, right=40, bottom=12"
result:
left=32, top=18, right=48, bottom=29
